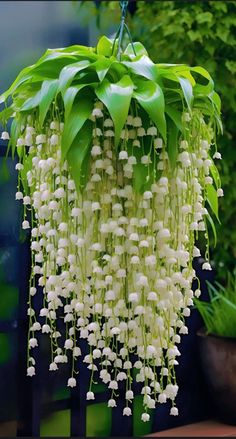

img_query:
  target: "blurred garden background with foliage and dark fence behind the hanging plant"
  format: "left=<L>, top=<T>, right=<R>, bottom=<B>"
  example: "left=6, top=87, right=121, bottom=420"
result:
left=0, top=0, right=236, bottom=437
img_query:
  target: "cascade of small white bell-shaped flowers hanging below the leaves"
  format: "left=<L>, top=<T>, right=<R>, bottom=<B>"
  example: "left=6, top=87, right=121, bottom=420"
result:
left=2, top=102, right=223, bottom=422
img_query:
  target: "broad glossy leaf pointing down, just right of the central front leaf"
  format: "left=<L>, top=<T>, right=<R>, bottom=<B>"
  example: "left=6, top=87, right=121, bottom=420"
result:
left=134, top=79, right=166, bottom=141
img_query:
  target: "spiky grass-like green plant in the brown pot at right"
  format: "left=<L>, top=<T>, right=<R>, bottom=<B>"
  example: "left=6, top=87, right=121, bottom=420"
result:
left=194, top=275, right=236, bottom=338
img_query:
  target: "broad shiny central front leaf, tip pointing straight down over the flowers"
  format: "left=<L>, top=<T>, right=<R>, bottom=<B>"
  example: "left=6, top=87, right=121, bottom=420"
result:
left=95, top=75, right=133, bottom=146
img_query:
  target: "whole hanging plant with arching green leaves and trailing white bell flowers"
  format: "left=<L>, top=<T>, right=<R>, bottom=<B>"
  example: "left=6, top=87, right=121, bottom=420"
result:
left=0, top=12, right=223, bottom=421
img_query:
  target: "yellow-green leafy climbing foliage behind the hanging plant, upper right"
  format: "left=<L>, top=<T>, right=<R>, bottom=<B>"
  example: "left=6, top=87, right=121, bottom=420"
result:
left=79, top=0, right=236, bottom=279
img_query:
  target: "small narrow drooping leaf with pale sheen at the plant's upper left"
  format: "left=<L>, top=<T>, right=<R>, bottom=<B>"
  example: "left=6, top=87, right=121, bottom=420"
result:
left=39, top=79, right=58, bottom=126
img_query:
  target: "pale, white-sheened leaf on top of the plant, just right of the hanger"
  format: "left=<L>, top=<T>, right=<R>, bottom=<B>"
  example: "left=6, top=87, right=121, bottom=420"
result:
left=122, top=55, right=158, bottom=81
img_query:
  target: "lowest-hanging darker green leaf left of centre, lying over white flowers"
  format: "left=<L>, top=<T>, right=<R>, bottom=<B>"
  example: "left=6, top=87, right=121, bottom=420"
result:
left=67, top=120, right=93, bottom=192
